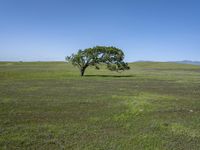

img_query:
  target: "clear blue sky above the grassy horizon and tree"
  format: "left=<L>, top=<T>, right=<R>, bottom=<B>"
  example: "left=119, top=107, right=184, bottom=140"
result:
left=0, top=0, right=200, bottom=62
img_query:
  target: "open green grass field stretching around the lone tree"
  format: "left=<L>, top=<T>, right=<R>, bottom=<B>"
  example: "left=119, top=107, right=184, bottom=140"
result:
left=0, top=62, right=200, bottom=150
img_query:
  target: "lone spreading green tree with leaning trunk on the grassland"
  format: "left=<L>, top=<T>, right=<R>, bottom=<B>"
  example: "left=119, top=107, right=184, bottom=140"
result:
left=66, top=46, right=130, bottom=76
